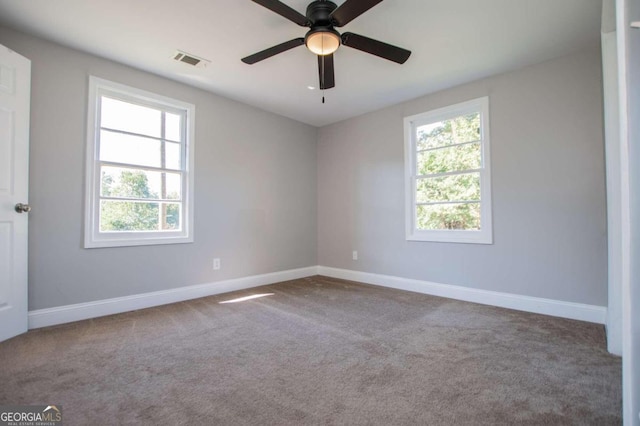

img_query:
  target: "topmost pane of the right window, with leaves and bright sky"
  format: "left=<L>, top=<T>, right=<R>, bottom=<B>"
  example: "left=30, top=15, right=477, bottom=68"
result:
left=416, top=113, right=480, bottom=151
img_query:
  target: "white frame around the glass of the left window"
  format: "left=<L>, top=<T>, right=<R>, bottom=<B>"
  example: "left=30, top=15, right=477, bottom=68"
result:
left=84, top=76, right=195, bottom=248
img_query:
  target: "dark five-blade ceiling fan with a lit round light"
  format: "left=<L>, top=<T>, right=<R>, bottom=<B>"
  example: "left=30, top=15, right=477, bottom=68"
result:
left=242, top=0, right=411, bottom=90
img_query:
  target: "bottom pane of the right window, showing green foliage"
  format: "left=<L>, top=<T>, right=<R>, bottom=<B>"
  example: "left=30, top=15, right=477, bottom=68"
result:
left=416, top=203, right=480, bottom=231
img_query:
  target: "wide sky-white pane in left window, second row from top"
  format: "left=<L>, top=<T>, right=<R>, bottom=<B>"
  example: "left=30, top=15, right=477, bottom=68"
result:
left=100, top=130, right=162, bottom=167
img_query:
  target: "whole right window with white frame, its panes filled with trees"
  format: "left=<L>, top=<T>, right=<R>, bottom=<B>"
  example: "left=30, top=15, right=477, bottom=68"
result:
left=404, top=97, right=492, bottom=244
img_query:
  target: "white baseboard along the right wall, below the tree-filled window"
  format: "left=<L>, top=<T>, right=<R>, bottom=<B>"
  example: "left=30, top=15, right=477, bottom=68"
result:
left=318, top=266, right=607, bottom=324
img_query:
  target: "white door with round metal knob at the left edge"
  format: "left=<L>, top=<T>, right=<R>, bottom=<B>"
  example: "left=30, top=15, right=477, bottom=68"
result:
left=0, top=45, right=31, bottom=341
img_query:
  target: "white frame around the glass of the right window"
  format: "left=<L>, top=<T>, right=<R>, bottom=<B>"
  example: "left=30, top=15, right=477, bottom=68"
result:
left=404, top=96, right=493, bottom=244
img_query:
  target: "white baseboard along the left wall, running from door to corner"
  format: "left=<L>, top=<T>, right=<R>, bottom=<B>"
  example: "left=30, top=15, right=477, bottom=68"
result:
left=29, top=266, right=318, bottom=329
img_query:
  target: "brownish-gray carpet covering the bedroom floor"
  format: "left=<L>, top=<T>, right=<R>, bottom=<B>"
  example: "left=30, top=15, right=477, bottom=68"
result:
left=0, top=277, right=621, bottom=425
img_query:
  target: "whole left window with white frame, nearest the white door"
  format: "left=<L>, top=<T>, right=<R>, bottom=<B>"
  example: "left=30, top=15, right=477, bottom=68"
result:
left=85, top=77, right=194, bottom=247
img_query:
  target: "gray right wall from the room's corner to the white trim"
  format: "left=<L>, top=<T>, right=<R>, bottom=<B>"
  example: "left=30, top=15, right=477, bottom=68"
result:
left=318, top=47, right=607, bottom=306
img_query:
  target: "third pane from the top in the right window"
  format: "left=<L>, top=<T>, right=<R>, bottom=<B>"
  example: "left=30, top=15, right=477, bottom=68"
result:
left=416, top=173, right=480, bottom=203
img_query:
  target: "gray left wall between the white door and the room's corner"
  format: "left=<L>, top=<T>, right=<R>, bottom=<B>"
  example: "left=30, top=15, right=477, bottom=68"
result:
left=0, top=28, right=317, bottom=310
